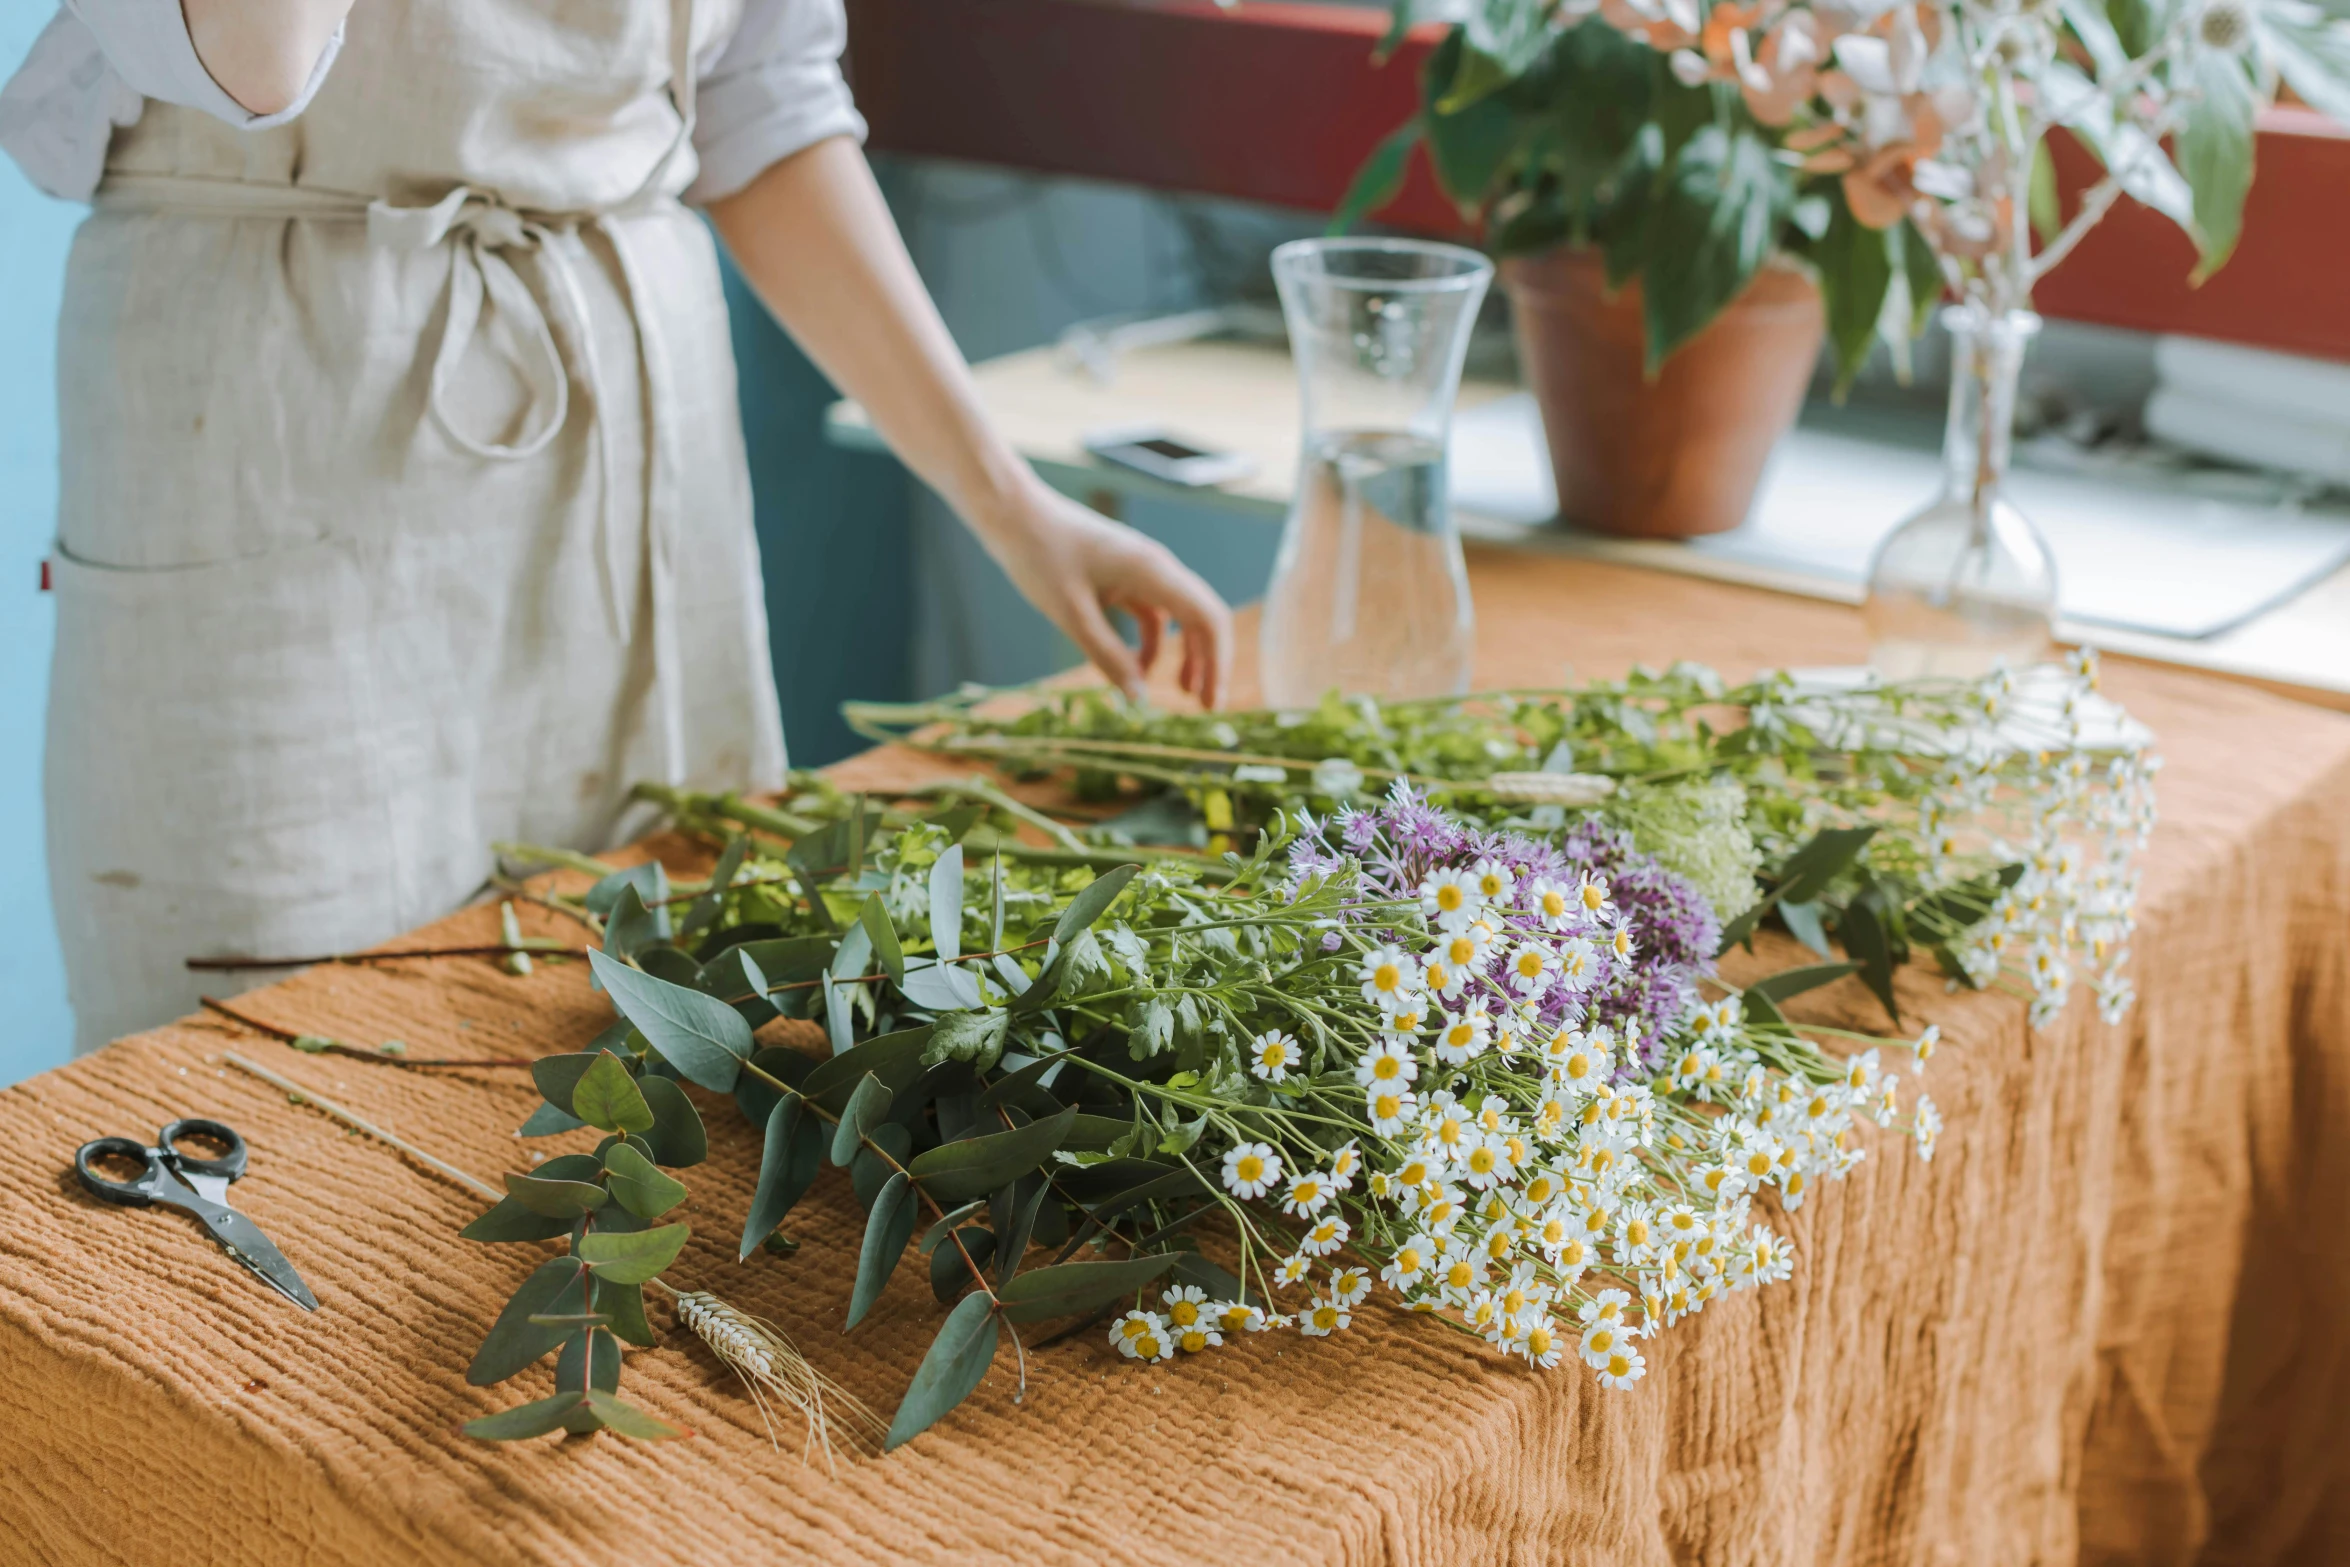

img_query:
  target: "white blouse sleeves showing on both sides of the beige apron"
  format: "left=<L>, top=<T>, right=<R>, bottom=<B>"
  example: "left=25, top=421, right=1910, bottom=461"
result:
left=0, top=0, right=865, bottom=202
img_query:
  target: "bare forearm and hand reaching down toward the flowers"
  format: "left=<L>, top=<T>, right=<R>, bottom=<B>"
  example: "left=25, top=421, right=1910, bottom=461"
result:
left=709, top=135, right=1231, bottom=707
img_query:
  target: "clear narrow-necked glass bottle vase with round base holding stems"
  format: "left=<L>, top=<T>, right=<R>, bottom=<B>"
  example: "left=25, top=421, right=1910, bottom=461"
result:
left=1864, top=305, right=2056, bottom=679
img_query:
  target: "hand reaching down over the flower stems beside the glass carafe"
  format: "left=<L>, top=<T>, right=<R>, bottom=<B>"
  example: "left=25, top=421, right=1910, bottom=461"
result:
left=980, top=482, right=1231, bottom=707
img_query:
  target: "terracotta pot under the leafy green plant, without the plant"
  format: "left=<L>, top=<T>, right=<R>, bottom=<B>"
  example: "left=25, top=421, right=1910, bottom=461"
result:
left=1502, top=247, right=1826, bottom=538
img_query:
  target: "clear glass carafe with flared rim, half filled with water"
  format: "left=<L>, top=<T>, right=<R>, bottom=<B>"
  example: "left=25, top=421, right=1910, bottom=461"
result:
left=1260, top=240, right=1492, bottom=709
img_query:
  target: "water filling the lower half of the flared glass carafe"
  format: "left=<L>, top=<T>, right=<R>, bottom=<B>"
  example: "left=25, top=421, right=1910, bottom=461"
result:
left=1264, top=430, right=1476, bottom=707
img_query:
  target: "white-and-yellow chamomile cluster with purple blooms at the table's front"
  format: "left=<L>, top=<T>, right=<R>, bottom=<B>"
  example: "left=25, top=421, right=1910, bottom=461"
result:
left=1109, top=787, right=1941, bottom=1388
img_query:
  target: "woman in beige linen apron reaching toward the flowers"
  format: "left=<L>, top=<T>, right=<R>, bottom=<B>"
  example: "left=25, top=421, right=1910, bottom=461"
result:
left=0, top=0, right=1231, bottom=1050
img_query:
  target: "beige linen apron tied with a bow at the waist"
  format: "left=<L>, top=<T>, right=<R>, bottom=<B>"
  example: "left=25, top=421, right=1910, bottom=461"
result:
left=47, top=0, right=783, bottom=1050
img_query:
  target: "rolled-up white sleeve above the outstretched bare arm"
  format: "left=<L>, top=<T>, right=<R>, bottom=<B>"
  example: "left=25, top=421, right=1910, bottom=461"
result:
left=686, top=0, right=865, bottom=202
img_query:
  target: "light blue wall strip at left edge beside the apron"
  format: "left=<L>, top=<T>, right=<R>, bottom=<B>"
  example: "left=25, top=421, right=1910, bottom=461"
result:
left=0, top=5, right=82, bottom=1083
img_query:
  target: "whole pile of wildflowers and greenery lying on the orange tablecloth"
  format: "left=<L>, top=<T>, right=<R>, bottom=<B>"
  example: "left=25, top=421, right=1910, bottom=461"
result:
left=468, top=670, right=2150, bottom=1445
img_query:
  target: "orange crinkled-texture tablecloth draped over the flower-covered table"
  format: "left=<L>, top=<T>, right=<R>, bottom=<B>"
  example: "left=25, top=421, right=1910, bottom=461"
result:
left=0, top=554, right=2350, bottom=1567
